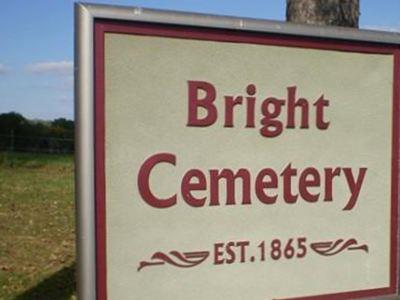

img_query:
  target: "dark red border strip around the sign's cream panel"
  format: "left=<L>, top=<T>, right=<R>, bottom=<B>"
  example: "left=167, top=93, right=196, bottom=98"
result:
left=94, top=19, right=400, bottom=300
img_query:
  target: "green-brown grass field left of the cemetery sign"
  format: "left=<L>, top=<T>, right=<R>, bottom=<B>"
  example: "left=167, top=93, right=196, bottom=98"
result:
left=0, top=152, right=75, bottom=300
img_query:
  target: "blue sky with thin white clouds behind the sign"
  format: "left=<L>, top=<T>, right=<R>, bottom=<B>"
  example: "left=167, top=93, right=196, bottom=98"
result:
left=0, top=0, right=400, bottom=120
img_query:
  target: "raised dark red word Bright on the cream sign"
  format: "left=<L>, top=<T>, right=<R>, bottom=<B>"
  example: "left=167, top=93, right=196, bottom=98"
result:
left=187, top=81, right=329, bottom=138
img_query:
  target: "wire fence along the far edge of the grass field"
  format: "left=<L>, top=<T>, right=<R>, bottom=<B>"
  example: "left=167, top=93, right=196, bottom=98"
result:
left=0, top=133, right=74, bottom=154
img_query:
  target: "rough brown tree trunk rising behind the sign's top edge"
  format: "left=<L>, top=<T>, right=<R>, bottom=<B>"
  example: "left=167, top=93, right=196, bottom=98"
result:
left=286, top=0, right=360, bottom=28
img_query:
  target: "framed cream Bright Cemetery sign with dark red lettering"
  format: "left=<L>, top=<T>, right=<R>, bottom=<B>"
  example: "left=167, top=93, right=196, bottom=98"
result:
left=77, top=5, right=400, bottom=300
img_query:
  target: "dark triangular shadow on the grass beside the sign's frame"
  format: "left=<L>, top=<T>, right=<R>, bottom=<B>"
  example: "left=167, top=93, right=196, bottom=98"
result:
left=14, top=262, right=76, bottom=300
